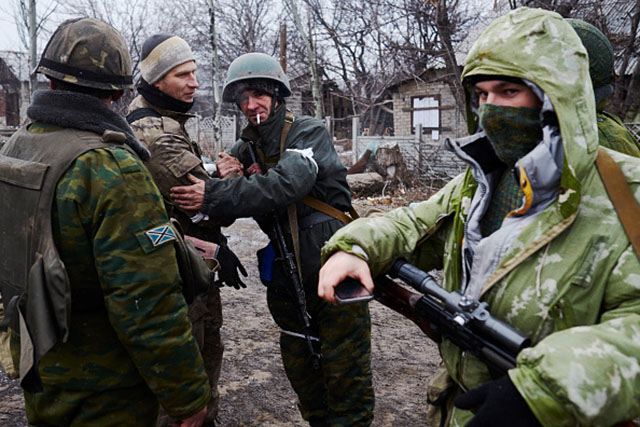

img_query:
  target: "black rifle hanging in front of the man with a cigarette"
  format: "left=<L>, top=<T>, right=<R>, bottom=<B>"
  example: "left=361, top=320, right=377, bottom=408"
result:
left=248, top=141, right=320, bottom=369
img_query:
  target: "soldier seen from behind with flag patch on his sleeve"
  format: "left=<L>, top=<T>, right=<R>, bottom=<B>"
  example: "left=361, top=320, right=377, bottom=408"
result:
left=0, top=18, right=211, bottom=426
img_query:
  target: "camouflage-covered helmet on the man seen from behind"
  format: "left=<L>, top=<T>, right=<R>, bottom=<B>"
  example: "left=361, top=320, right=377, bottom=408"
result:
left=36, top=18, right=133, bottom=90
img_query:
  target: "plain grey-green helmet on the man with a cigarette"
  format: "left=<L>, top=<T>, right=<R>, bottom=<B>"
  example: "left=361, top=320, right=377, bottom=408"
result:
left=222, top=52, right=291, bottom=102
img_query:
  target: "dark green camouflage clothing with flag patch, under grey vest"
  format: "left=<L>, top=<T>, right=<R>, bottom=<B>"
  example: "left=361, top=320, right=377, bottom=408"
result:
left=12, top=132, right=210, bottom=425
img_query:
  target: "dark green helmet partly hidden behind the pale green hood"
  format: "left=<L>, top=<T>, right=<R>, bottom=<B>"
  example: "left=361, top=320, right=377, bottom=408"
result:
left=567, top=19, right=614, bottom=104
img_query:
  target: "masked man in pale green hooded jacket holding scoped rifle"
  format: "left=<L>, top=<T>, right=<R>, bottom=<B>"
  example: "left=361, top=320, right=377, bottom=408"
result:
left=318, top=8, right=640, bottom=426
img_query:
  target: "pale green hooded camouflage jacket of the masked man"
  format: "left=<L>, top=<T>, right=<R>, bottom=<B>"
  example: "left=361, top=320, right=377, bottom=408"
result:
left=323, top=8, right=640, bottom=426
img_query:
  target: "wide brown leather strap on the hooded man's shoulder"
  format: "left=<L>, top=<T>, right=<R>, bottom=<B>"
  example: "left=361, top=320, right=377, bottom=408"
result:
left=596, top=149, right=640, bottom=260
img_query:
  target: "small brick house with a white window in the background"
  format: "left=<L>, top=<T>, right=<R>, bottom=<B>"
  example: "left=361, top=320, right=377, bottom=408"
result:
left=387, top=69, right=467, bottom=141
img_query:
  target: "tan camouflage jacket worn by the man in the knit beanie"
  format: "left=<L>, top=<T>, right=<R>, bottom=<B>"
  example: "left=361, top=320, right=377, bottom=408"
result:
left=129, top=95, right=225, bottom=243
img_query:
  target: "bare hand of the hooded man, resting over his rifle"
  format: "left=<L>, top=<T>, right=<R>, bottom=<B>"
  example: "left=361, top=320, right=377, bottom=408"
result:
left=318, top=251, right=374, bottom=304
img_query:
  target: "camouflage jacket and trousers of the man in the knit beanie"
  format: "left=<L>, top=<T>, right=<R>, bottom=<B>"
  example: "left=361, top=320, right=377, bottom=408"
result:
left=129, top=96, right=226, bottom=426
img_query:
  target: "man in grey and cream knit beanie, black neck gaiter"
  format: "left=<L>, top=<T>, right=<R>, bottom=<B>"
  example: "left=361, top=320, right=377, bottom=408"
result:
left=127, top=34, right=246, bottom=425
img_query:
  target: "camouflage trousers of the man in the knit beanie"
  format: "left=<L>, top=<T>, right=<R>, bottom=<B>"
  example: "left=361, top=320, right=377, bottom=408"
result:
left=157, top=288, right=224, bottom=427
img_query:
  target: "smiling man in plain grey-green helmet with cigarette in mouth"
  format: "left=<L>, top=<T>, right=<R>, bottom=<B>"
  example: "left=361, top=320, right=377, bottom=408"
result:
left=172, top=53, right=374, bottom=426
